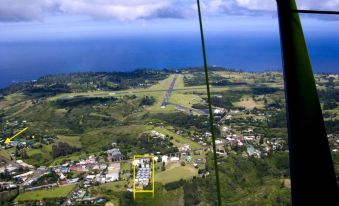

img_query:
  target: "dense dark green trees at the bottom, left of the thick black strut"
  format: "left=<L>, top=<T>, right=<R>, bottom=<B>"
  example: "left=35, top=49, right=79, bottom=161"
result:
left=184, top=153, right=290, bottom=205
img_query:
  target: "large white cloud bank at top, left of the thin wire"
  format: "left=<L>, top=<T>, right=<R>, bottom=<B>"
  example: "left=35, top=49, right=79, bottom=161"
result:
left=0, top=0, right=184, bottom=22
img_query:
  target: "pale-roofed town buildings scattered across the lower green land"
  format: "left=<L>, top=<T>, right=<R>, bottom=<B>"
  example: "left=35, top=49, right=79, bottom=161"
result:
left=0, top=104, right=339, bottom=205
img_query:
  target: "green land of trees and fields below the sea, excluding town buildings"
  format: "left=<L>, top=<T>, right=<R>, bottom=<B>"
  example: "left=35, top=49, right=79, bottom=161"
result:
left=0, top=68, right=339, bottom=206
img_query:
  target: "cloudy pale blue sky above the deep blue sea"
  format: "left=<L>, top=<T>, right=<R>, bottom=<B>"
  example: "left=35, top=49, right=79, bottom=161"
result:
left=0, top=0, right=339, bottom=42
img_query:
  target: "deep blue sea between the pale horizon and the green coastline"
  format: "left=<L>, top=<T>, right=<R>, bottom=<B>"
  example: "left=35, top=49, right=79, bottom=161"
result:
left=0, top=34, right=339, bottom=87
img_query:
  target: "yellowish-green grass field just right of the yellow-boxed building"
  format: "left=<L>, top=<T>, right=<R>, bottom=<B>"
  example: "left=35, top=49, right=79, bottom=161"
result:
left=155, top=163, right=198, bottom=184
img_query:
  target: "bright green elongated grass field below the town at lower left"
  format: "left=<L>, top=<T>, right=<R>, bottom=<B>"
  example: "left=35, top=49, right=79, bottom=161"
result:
left=14, top=185, right=75, bottom=202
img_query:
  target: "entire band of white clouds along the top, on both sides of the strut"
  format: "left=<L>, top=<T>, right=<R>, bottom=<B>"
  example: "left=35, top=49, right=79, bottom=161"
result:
left=0, top=0, right=339, bottom=22
